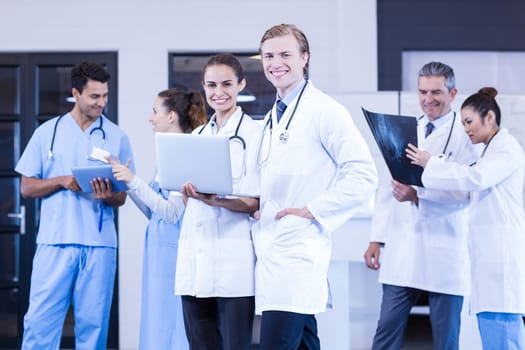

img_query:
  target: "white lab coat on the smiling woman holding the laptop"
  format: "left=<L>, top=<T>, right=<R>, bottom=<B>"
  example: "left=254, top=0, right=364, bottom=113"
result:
left=175, top=108, right=262, bottom=298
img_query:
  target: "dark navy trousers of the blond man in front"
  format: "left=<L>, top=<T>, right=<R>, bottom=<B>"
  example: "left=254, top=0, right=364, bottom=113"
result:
left=260, top=311, right=321, bottom=350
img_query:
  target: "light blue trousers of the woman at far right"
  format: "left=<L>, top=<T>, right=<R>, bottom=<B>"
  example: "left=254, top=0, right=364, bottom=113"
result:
left=477, top=312, right=525, bottom=350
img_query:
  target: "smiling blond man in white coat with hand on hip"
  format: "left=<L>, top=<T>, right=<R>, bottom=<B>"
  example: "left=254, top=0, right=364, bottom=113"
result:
left=253, top=24, right=377, bottom=350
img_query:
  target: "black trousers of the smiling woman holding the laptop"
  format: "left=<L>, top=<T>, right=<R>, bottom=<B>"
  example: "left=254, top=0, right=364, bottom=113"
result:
left=180, top=295, right=255, bottom=350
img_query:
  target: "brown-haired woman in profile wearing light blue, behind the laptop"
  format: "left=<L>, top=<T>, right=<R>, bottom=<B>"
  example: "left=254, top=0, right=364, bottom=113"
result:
left=113, top=89, right=206, bottom=350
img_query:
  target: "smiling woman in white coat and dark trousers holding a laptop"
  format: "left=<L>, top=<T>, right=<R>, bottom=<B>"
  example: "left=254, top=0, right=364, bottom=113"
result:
left=175, top=54, right=261, bottom=350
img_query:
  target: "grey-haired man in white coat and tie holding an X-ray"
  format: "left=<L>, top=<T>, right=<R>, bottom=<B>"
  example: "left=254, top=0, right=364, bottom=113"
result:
left=365, top=62, right=479, bottom=350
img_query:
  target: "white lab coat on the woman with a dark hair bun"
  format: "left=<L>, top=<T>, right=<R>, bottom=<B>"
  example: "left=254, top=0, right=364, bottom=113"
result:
left=423, top=129, right=525, bottom=314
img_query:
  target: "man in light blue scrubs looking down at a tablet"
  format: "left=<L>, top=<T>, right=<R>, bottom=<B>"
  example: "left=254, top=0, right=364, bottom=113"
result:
left=15, top=62, right=134, bottom=350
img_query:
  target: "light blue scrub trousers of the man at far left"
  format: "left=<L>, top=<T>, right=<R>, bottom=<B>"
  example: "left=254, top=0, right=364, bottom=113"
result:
left=22, top=244, right=117, bottom=350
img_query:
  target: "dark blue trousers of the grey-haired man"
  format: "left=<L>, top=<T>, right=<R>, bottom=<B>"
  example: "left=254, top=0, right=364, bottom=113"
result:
left=372, top=284, right=463, bottom=350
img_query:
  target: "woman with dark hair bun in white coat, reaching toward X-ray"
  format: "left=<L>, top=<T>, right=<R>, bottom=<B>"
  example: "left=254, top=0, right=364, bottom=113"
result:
left=407, top=88, right=525, bottom=350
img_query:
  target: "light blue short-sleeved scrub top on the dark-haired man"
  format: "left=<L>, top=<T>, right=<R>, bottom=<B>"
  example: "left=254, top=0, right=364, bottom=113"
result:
left=15, top=113, right=135, bottom=247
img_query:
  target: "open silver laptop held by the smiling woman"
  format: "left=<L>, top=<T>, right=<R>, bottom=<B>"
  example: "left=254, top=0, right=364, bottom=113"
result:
left=155, top=133, right=233, bottom=195
